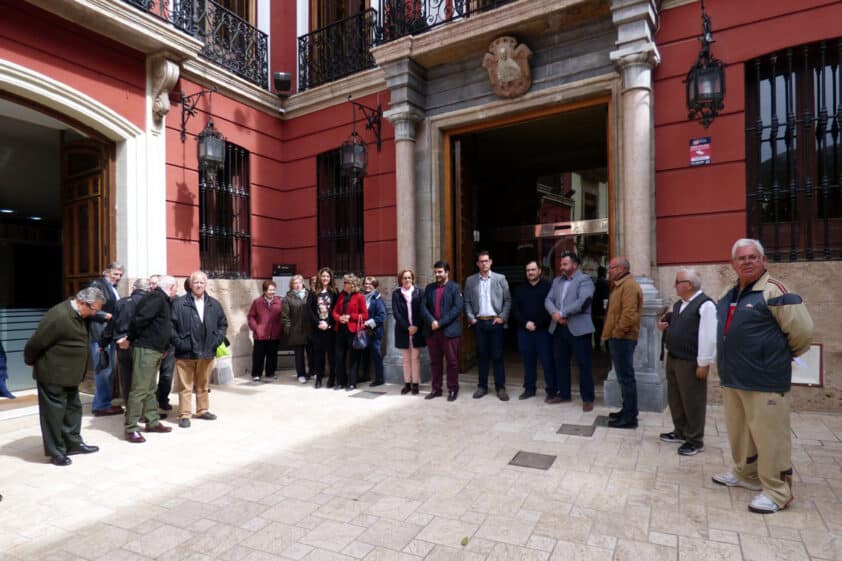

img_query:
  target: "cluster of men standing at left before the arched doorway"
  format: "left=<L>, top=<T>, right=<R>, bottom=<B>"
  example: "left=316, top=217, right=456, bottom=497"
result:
left=24, top=263, right=228, bottom=466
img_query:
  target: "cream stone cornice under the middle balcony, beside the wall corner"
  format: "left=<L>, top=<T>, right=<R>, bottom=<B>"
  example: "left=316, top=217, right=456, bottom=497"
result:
left=284, top=68, right=386, bottom=119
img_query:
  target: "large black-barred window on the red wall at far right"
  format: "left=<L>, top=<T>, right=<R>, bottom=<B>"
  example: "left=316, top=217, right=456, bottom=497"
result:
left=746, top=38, right=842, bottom=261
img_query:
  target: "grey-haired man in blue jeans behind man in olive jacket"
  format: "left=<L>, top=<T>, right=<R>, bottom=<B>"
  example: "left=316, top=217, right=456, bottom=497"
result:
left=91, top=261, right=126, bottom=417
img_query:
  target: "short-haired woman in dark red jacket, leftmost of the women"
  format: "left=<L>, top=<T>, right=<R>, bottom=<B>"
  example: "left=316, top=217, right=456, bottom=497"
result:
left=248, top=280, right=283, bottom=382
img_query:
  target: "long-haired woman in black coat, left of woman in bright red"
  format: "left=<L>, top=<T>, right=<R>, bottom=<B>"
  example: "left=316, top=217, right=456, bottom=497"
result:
left=307, top=267, right=337, bottom=388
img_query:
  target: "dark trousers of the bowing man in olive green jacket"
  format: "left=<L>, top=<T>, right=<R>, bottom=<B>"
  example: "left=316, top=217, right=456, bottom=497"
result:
left=38, top=382, right=82, bottom=457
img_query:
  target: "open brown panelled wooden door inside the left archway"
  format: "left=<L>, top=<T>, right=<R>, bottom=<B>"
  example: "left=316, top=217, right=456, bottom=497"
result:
left=61, top=139, right=111, bottom=297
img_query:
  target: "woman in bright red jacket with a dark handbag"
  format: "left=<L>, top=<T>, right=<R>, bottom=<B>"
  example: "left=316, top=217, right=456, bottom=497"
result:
left=331, top=275, right=368, bottom=390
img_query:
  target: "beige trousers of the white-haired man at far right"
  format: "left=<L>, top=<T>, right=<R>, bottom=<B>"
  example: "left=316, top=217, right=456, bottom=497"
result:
left=722, top=388, right=792, bottom=507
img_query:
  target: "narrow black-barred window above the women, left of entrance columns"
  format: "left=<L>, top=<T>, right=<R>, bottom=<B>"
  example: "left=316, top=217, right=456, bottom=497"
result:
left=316, top=150, right=364, bottom=273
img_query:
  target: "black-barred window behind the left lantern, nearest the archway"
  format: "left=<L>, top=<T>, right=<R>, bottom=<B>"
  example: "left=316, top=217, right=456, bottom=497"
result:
left=199, top=142, right=251, bottom=279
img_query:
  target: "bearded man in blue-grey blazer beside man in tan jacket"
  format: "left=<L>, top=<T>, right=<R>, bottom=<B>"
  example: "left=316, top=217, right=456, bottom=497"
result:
left=544, top=252, right=594, bottom=411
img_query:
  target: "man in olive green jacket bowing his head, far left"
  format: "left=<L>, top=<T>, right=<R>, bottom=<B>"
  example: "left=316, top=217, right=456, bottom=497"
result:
left=23, top=287, right=105, bottom=466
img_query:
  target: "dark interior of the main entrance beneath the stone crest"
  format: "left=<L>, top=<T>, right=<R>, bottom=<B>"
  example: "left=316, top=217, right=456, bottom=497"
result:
left=451, top=104, right=610, bottom=396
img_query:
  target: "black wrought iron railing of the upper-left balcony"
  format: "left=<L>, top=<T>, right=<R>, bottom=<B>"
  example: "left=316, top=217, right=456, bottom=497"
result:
left=123, top=0, right=269, bottom=88
